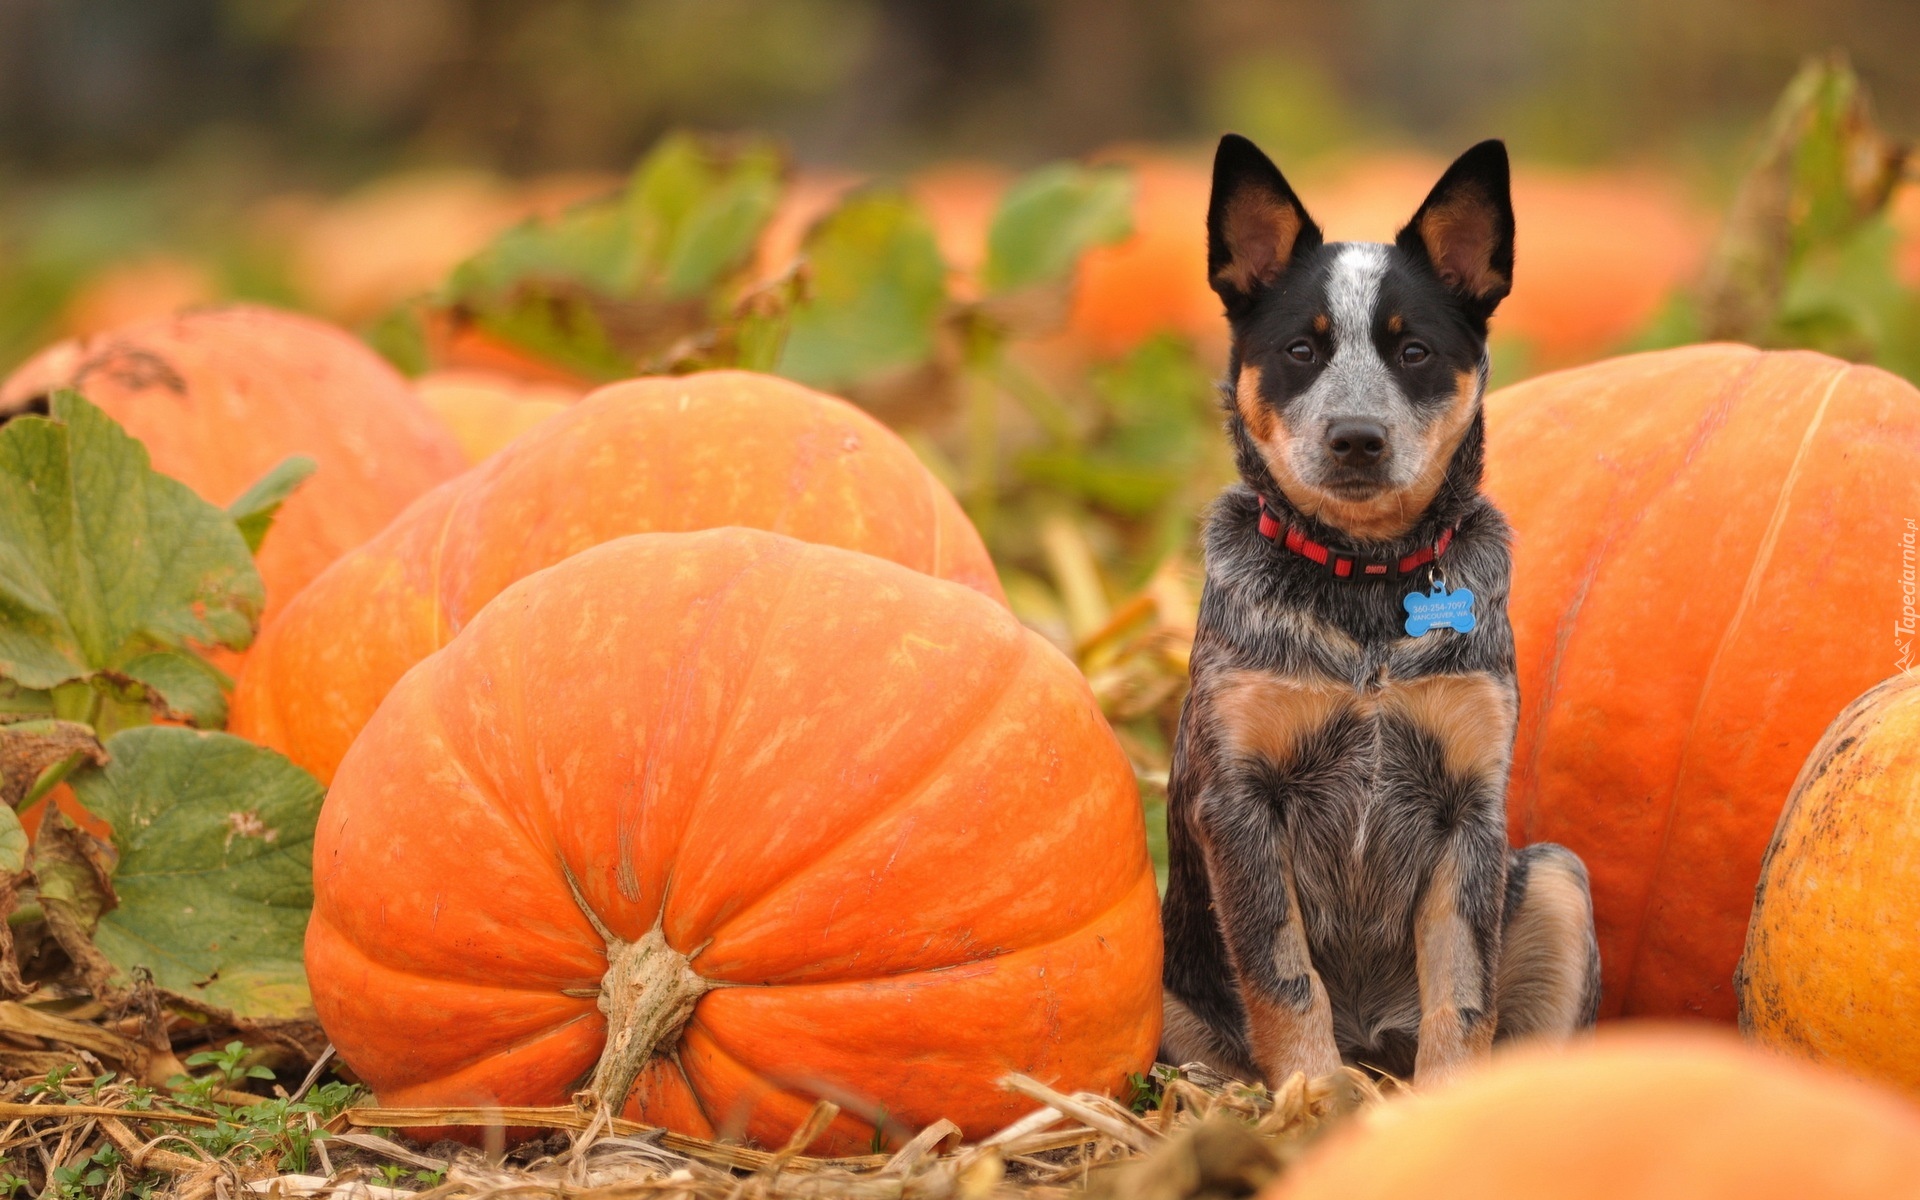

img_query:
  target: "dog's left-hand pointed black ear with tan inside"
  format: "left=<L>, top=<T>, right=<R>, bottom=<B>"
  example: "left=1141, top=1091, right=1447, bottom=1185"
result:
left=1206, top=132, right=1321, bottom=315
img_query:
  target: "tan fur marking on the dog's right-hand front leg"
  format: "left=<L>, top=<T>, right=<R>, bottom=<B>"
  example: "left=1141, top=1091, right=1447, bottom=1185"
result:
left=1413, top=851, right=1494, bottom=1083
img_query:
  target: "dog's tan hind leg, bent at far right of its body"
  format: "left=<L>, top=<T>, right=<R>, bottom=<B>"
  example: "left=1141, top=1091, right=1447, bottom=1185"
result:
left=1496, top=858, right=1594, bottom=1043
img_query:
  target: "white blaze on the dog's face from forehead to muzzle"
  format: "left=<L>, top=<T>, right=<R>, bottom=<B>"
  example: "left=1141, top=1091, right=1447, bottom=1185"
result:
left=1290, top=242, right=1419, bottom=486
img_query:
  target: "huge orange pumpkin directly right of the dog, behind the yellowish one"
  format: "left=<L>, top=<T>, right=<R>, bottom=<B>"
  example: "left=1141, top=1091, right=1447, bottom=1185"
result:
left=1486, top=346, right=1920, bottom=1020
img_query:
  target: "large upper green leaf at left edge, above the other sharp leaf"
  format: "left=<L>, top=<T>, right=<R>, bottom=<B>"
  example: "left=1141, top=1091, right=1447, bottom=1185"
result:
left=0, top=392, right=265, bottom=687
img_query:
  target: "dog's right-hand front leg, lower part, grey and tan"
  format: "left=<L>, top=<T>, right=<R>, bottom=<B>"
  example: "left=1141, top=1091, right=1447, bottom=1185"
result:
left=1413, top=804, right=1507, bottom=1085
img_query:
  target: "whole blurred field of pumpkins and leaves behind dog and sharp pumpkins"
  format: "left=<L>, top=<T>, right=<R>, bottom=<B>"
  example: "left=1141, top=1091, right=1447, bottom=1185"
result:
left=0, top=0, right=1920, bottom=860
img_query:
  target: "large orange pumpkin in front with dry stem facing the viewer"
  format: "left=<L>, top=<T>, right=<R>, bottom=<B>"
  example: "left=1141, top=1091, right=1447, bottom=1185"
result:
left=307, top=528, right=1160, bottom=1152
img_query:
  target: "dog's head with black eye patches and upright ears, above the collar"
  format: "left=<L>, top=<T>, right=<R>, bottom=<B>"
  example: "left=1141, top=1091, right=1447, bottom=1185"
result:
left=1208, top=134, right=1513, bottom=540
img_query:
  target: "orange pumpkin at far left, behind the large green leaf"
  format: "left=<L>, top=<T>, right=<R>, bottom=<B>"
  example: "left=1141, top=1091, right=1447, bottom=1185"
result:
left=0, top=307, right=467, bottom=645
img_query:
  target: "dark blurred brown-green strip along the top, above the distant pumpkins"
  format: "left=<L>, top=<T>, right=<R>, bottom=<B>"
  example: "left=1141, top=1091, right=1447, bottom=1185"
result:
left=0, top=0, right=1920, bottom=171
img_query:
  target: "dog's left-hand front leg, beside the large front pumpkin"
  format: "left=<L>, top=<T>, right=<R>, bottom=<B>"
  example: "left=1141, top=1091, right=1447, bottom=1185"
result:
left=1200, top=785, right=1340, bottom=1087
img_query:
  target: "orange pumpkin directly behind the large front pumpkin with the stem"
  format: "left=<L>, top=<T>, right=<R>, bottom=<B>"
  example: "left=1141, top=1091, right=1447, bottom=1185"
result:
left=232, top=371, right=1000, bottom=780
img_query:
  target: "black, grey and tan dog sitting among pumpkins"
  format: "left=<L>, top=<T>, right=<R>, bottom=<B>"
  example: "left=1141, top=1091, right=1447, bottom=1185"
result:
left=1162, top=134, right=1599, bottom=1087
